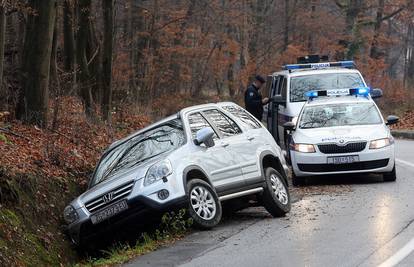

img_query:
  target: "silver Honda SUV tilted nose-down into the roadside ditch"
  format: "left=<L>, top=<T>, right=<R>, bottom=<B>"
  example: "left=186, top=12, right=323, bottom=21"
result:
left=64, top=102, right=290, bottom=247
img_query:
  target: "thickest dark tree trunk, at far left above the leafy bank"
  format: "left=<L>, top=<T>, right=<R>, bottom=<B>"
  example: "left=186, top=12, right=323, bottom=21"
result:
left=16, top=0, right=56, bottom=127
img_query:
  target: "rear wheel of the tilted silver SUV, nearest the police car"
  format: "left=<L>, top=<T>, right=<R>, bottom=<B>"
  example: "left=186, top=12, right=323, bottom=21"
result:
left=262, top=168, right=290, bottom=217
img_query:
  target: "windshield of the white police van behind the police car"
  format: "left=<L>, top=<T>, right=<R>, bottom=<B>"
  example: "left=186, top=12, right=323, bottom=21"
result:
left=290, top=73, right=365, bottom=102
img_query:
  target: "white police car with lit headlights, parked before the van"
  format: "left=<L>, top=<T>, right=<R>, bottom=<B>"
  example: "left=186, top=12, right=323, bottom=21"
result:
left=284, top=87, right=399, bottom=185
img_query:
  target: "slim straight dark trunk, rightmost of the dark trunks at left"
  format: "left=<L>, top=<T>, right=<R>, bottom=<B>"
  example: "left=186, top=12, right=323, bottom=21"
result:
left=101, top=0, right=114, bottom=121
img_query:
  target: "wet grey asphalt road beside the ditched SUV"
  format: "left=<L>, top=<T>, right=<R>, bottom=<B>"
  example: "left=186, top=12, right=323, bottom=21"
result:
left=127, top=140, right=414, bottom=267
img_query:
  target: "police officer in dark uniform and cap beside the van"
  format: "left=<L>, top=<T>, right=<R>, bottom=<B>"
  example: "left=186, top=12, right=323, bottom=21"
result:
left=244, top=75, right=269, bottom=121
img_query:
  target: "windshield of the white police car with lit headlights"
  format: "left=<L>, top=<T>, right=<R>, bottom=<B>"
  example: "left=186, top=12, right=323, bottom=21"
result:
left=299, top=103, right=382, bottom=129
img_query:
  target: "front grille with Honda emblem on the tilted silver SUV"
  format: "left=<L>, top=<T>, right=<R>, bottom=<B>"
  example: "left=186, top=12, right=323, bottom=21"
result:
left=85, top=181, right=134, bottom=213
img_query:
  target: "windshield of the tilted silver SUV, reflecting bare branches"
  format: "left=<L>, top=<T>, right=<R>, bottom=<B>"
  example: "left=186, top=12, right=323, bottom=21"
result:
left=91, top=119, right=185, bottom=187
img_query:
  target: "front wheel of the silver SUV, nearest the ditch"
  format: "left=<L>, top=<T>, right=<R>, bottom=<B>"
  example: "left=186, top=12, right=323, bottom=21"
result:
left=187, top=179, right=222, bottom=229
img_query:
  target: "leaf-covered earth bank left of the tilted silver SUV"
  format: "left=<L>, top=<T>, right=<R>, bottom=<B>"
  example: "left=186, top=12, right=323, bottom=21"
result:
left=0, top=99, right=149, bottom=266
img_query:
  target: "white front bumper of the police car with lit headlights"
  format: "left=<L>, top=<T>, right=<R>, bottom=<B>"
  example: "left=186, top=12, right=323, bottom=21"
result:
left=291, top=145, right=395, bottom=176
